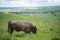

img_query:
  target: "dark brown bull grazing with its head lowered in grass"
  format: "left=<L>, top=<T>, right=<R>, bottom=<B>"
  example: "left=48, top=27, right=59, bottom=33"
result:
left=8, top=21, right=37, bottom=35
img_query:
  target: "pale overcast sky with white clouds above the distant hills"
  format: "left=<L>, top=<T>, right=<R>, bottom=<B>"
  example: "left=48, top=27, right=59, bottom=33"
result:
left=0, top=0, right=60, bottom=7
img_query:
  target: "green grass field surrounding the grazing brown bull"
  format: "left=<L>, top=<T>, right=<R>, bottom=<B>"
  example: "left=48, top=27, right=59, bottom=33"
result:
left=0, top=14, right=60, bottom=40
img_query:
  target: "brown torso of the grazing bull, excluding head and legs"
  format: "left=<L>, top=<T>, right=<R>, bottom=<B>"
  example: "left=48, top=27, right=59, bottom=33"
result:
left=9, top=21, right=32, bottom=30
